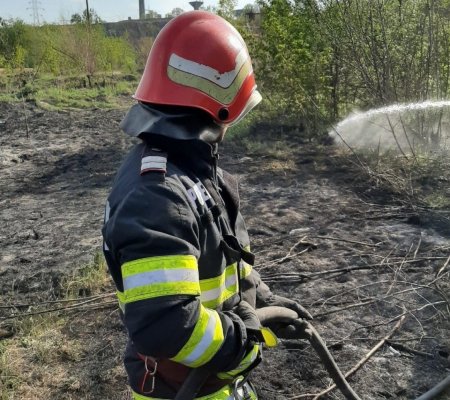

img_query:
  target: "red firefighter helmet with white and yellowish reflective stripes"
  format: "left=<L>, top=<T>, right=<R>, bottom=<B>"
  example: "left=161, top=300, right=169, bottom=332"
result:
left=134, top=11, right=261, bottom=124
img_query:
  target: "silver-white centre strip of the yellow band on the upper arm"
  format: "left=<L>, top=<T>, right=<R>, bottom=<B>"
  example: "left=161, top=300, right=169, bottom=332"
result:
left=123, top=268, right=198, bottom=290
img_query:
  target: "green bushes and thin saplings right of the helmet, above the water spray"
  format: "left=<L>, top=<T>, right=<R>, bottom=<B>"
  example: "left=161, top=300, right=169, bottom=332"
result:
left=227, top=0, right=450, bottom=136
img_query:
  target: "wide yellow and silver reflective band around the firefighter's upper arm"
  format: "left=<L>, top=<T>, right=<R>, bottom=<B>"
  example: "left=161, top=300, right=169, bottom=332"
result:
left=120, top=255, right=200, bottom=303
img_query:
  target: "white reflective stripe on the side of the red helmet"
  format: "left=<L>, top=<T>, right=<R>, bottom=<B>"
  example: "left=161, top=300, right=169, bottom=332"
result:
left=169, top=48, right=248, bottom=88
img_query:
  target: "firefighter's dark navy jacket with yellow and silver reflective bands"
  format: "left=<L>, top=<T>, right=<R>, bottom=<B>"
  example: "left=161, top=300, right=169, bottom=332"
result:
left=103, top=105, right=265, bottom=398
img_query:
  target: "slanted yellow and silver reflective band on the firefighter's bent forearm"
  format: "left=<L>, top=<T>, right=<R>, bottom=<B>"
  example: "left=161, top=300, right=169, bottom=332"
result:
left=171, top=305, right=224, bottom=368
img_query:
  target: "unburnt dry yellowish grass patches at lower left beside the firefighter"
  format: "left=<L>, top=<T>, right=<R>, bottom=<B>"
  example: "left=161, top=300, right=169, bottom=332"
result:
left=0, top=255, right=110, bottom=400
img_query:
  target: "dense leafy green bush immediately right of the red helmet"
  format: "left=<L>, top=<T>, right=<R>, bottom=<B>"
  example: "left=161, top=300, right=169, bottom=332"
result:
left=249, top=0, right=330, bottom=137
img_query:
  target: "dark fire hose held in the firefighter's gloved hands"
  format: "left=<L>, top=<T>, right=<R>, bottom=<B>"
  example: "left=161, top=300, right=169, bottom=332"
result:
left=174, top=306, right=361, bottom=400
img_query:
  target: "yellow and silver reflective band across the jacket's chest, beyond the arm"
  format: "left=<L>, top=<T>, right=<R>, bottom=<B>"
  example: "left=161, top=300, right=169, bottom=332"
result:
left=200, top=263, right=238, bottom=308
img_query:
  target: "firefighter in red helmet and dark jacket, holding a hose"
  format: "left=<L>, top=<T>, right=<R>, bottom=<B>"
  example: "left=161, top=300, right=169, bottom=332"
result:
left=103, top=11, right=310, bottom=400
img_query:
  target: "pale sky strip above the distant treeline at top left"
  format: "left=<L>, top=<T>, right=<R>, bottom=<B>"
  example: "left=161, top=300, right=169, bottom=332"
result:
left=0, top=0, right=253, bottom=23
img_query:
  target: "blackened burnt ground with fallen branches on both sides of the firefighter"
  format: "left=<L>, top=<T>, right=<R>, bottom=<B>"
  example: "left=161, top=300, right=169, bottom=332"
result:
left=0, top=104, right=450, bottom=400
